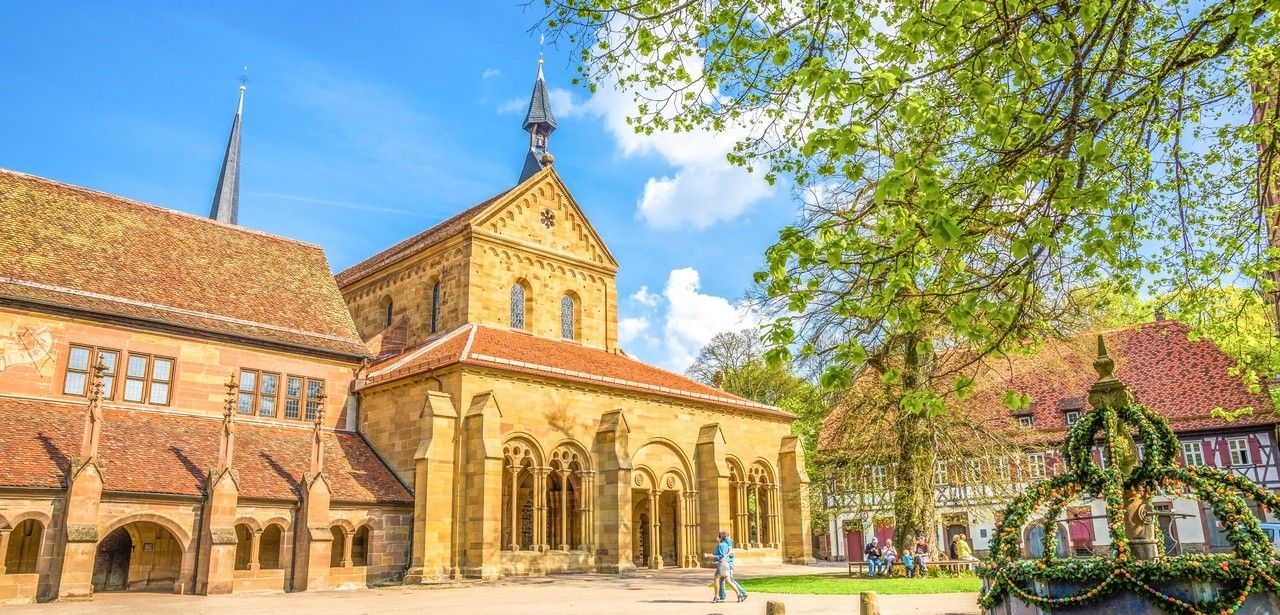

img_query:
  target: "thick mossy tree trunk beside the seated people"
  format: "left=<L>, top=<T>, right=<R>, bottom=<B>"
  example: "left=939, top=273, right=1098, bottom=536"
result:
left=893, top=336, right=937, bottom=551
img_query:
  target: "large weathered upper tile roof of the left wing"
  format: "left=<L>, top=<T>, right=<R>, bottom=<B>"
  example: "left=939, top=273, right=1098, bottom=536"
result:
left=0, top=169, right=366, bottom=357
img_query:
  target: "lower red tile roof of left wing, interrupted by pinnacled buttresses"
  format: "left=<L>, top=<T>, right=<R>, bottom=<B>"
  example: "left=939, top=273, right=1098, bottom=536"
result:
left=0, top=398, right=413, bottom=504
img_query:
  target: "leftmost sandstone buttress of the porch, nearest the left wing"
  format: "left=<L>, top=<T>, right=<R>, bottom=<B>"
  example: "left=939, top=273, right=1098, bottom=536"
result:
left=404, top=391, right=458, bottom=583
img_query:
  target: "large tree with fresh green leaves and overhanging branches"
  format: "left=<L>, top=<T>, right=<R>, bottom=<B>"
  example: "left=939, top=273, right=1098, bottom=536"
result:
left=547, top=0, right=1280, bottom=548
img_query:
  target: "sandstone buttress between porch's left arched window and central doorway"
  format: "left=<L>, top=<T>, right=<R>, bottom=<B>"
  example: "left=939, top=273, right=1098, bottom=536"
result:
left=591, top=410, right=636, bottom=573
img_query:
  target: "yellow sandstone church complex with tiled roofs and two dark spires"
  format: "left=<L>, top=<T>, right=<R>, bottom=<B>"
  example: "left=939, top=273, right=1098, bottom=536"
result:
left=0, top=67, right=810, bottom=603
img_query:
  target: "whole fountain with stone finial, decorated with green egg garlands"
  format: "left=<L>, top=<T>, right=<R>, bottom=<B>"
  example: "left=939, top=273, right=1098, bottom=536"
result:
left=978, top=336, right=1280, bottom=615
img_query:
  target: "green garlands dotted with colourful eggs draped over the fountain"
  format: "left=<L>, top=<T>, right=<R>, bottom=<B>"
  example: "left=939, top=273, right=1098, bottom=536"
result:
left=978, top=405, right=1280, bottom=615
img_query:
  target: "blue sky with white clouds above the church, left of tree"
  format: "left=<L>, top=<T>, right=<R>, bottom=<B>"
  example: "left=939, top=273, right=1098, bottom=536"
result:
left=0, top=0, right=794, bottom=369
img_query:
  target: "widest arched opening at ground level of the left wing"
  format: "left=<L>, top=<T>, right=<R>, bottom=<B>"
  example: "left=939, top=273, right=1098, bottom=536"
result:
left=93, top=521, right=182, bottom=592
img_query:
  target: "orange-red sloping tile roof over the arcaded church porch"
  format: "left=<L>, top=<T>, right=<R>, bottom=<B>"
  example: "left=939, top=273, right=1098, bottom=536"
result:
left=366, top=324, right=794, bottom=419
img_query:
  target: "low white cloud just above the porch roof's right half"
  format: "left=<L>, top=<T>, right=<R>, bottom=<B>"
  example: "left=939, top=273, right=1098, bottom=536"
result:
left=662, top=268, right=760, bottom=372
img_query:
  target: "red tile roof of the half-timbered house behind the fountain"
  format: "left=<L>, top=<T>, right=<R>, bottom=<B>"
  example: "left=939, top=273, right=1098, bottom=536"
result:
left=820, top=320, right=1280, bottom=448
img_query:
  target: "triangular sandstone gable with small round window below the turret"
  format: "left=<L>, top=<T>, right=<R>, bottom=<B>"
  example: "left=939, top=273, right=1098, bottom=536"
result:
left=471, top=169, right=618, bottom=272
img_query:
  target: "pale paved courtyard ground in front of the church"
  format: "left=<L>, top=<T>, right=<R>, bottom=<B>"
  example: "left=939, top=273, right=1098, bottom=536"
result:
left=0, top=566, right=978, bottom=615
